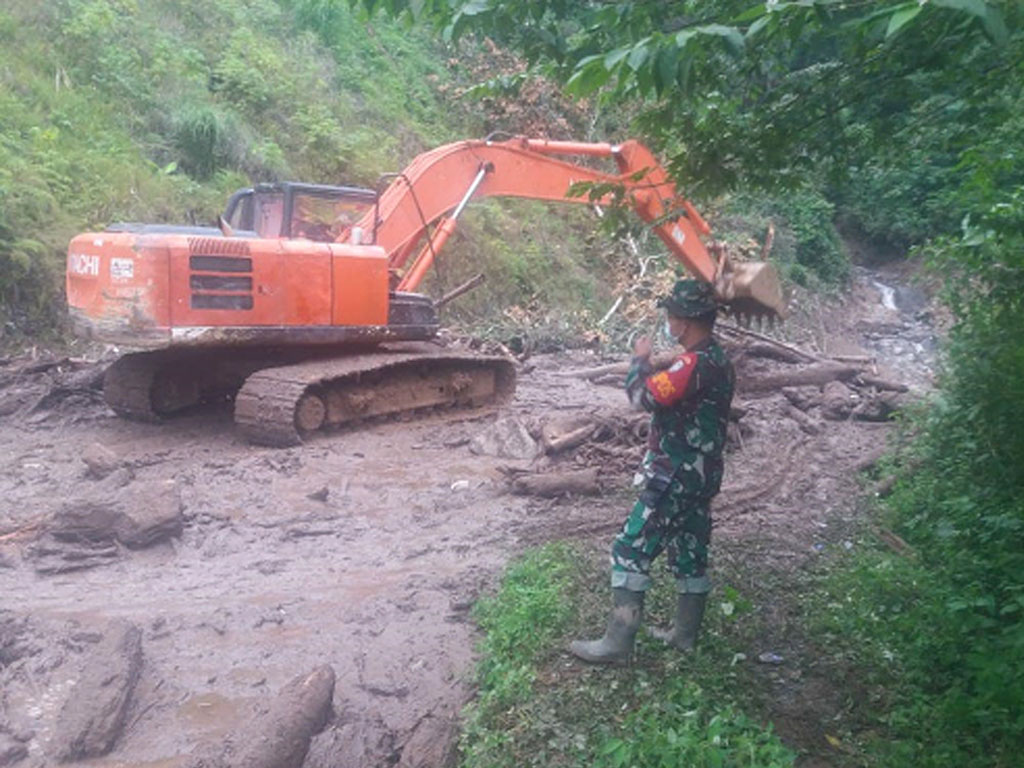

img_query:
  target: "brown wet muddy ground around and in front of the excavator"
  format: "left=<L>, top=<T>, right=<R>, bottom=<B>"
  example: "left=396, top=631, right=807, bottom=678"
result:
left=0, top=262, right=934, bottom=768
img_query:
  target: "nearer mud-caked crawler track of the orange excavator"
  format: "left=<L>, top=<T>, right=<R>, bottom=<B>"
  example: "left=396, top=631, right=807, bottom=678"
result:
left=234, top=344, right=515, bottom=447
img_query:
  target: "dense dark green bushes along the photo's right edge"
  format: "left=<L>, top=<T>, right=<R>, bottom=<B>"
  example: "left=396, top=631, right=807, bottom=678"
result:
left=825, top=186, right=1024, bottom=768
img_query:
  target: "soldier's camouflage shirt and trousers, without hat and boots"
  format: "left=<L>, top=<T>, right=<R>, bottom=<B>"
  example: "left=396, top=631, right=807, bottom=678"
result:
left=611, top=337, right=735, bottom=594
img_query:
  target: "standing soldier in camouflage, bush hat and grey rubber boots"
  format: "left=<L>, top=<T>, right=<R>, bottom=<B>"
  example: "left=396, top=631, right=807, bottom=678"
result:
left=569, top=280, right=735, bottom=664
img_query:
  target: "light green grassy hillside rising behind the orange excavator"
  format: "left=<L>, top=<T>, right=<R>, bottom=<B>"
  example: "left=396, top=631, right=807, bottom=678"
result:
left=0, top=0, right=604, bottom=339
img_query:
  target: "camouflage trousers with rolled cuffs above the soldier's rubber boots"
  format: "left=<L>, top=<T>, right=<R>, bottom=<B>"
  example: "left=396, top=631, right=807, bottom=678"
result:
left=611, top=480, right=711, bottom=594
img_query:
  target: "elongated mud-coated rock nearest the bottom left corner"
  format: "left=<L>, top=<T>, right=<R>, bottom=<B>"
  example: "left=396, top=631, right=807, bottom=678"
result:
left=50, top=621, right=142, bottom=762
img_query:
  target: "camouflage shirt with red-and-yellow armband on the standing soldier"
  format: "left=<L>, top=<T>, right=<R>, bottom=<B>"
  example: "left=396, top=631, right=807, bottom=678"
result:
left=626, top=337, right=735, bottom=499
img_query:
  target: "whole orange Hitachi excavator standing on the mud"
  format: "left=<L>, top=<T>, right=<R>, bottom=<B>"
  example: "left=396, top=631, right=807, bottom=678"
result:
left=67, top=137, right=784, bottom=445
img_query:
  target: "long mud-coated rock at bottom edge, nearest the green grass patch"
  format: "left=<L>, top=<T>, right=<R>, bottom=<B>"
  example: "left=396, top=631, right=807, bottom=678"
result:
left=199, top=665, right=335, bottom=768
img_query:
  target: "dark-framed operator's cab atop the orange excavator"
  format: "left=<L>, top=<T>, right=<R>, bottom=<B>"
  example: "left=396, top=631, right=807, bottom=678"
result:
left=223, top=181, right=377, bottom=245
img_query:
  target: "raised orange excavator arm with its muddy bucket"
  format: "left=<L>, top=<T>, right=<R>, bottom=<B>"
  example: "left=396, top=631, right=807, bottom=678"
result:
left=357, top=137, right=784, bottom=316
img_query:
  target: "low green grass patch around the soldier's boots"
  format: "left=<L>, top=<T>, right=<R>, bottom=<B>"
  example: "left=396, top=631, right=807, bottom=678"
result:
left=461, top=544, right=794, bottom=768
